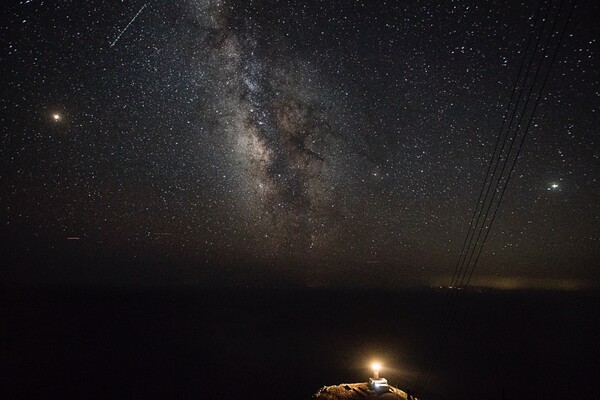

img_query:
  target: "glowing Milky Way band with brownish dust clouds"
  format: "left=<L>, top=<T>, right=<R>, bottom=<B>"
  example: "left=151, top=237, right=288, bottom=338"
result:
left=185, top=2, right=354, bottom=257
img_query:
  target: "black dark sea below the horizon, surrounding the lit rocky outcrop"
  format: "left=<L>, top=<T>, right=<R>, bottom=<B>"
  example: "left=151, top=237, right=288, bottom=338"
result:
left=0, top=287, right=600, bottom=400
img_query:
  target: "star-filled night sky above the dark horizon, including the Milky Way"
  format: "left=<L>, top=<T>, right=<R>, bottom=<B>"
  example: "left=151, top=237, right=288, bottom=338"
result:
left=0, top=0, right=600, bottom=289
